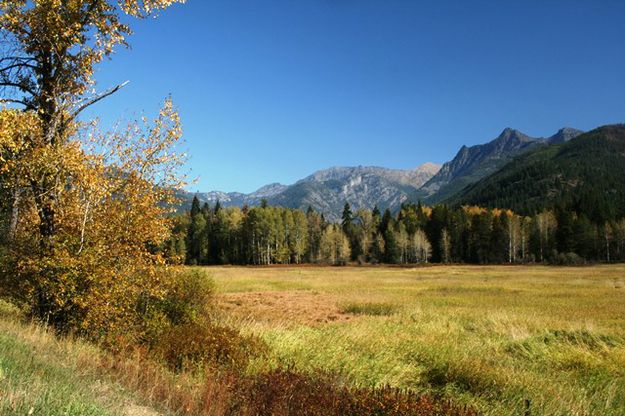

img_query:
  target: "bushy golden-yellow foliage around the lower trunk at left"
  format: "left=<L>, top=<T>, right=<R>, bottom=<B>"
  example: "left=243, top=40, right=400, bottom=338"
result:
left=0, top=101, right=188, bottom=341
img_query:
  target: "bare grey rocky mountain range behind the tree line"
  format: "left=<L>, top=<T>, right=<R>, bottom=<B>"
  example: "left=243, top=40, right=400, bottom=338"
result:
left=185, top=127, right=582, bottom=220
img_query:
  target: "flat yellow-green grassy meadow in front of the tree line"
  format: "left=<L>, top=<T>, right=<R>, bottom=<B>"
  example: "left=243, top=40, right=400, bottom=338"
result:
left=207, top=265, right=625, bottom=415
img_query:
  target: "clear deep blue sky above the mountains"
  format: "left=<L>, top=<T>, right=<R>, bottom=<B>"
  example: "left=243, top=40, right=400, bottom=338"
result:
left=85, top=0, right=625, bottom=192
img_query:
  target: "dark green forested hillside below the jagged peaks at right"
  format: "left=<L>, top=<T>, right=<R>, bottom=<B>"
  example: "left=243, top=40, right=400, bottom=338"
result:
left=450, top=124, right=625, bottom=223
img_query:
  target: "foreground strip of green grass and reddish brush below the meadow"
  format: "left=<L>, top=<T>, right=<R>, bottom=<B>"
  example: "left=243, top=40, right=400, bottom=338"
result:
left=0, top=305, right=475, bottom=416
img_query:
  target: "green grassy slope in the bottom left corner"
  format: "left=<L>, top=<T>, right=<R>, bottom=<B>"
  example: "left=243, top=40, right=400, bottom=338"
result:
left=0, top=302, right=158, bottom=416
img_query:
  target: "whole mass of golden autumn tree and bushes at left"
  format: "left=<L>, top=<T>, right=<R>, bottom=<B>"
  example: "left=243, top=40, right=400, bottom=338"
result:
left=0, top=0, right=184, bottom=338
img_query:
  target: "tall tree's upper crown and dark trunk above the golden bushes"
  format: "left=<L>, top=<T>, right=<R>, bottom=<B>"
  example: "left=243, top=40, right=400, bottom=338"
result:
left=0, top=0, right=183, bottom=250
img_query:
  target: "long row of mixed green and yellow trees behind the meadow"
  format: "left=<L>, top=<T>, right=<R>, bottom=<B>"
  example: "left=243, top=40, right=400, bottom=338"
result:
left=165, top=197, right=625, bottom=265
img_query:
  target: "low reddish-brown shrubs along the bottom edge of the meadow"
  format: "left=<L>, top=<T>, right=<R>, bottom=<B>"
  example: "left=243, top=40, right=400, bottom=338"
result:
left=94, top=354, right=477, bottom=416
